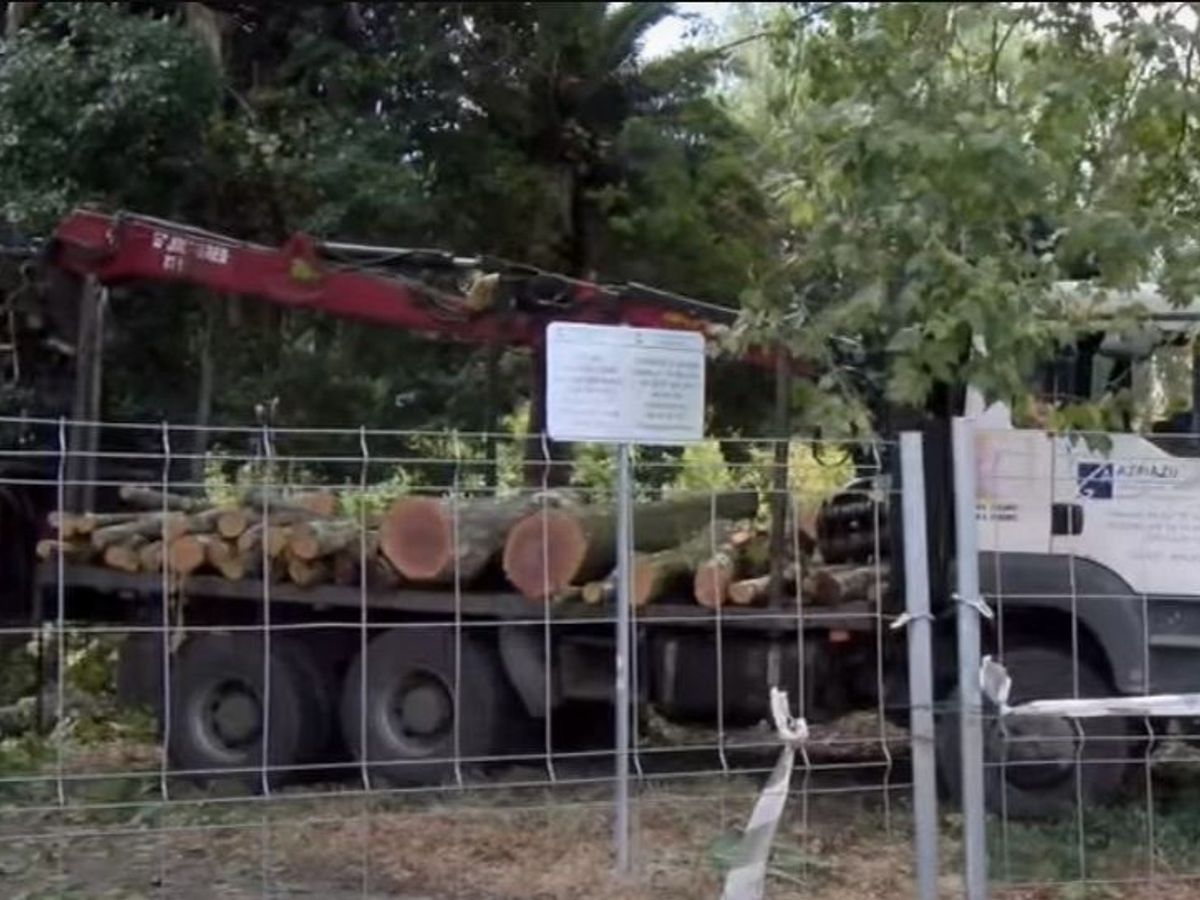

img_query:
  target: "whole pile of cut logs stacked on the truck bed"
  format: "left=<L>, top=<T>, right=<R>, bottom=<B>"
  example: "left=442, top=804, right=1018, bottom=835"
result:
left=37, top=486, right=888, bottom=608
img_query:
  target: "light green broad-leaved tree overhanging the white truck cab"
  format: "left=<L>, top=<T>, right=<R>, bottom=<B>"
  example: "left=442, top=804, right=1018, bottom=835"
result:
left=724, top=4, right=1200, bottom=434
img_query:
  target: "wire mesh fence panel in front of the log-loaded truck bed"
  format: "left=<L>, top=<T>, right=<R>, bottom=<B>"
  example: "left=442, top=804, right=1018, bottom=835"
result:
left=0, top=415, right=926, bottom=898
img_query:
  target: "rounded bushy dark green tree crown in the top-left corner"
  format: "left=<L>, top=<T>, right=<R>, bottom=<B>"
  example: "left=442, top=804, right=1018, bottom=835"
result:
left=0, top=4, right=220, bottom=230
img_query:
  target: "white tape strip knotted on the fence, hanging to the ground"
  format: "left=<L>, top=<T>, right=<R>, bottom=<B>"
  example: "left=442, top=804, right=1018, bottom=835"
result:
left=721, top=688, right=809, bottom=900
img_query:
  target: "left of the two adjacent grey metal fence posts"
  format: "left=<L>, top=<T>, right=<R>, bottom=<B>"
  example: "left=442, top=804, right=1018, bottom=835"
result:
left=900, top=432, right=937, bottom=900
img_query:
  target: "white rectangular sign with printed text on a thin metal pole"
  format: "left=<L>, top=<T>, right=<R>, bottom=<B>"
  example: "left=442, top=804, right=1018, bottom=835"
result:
left=546, top=322, right=704, bottom=444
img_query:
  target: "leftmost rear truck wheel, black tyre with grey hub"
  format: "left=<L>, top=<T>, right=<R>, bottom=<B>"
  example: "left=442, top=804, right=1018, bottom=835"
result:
left=167, top=634, right=331, bottom=791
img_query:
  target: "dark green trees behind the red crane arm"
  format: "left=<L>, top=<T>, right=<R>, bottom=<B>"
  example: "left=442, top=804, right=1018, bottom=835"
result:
left=0, top=2, right=766, bottom=444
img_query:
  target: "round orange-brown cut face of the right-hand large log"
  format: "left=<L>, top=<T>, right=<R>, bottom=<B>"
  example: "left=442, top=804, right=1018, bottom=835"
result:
left=504, top=510, right=588, bottom=600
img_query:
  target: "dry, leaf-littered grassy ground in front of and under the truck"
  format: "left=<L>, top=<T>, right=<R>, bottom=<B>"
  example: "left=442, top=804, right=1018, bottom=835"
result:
left=7, top=729, right=1200, bottom=900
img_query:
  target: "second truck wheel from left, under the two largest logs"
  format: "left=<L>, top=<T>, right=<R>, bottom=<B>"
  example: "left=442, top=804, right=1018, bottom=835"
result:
left=342, top=626, right=520, bottom=785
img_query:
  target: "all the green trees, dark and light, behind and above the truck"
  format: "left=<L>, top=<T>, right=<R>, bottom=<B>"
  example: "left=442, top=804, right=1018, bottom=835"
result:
left=0, top=2, right=1200, bottom=434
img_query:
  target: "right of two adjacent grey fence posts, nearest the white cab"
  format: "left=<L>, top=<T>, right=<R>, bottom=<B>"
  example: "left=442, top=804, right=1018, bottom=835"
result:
left=953, top=416, right=988, bottom=900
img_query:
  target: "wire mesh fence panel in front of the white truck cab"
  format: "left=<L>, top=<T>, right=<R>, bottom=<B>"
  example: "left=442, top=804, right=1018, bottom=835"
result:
left=969, top=420, right=1200, bottom=898
